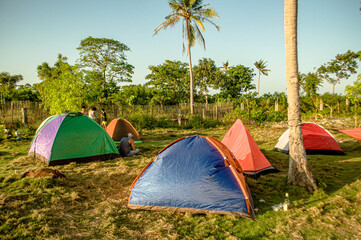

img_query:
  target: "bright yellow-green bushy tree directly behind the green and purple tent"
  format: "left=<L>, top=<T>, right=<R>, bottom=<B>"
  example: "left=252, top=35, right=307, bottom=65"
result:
left=37, top=54, right=85, bottom=114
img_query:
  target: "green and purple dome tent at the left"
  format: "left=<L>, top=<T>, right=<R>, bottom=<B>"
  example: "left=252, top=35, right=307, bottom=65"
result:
left=28, top=113, right=119, bottom=166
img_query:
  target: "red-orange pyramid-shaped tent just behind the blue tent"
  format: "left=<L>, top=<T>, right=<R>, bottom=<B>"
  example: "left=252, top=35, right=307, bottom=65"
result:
left=222, top=119, right=278, bottom=178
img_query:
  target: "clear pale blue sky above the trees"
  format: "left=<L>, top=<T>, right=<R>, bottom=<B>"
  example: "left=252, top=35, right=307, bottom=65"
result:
left=0, top=0, right=361, bottom=95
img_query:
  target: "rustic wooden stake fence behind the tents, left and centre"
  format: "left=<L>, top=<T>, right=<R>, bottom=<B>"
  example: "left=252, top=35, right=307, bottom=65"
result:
left=0, top=101, right=233, bottom=127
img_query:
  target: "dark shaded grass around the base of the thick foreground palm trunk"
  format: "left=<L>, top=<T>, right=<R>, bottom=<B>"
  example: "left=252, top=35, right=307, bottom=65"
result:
left=247, top=142, right=361, bottom=215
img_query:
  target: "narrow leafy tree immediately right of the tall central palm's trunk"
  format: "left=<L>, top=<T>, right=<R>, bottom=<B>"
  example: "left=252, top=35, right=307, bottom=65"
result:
left=193, top=58, right=218, bottom=104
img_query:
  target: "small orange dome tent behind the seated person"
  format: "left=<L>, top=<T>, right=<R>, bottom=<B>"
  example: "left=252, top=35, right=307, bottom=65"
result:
left=105, top=118, right=140, bottom=141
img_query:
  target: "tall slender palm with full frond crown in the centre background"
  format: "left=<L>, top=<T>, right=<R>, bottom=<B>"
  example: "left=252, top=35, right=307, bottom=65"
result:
left=153, top=0, right=220, bottom=114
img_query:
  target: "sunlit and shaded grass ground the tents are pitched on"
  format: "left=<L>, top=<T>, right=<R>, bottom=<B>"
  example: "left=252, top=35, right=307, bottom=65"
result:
left=0, top=123, right=361, bottom=239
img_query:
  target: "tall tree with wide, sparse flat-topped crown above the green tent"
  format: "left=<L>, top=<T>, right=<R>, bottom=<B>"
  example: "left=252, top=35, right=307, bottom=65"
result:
left=77, top=37, right=134, bottom=102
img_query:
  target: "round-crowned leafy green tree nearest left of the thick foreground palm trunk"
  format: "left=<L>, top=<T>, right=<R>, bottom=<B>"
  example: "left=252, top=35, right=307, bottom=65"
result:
left=215, top=65, right=256, bottom=99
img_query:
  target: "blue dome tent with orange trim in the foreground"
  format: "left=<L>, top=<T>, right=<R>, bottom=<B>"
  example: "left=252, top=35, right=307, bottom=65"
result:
left=128, top=136, right=255, bottom=219
